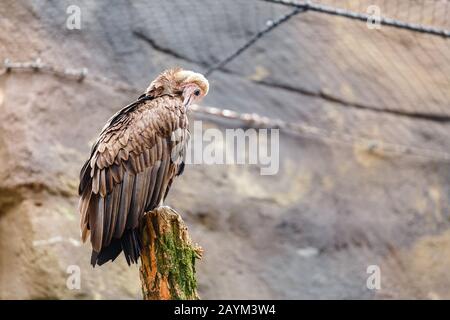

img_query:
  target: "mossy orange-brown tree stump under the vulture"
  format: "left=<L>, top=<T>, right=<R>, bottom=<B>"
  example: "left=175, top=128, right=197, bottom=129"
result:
left=140, top=207, right=202, bottom=300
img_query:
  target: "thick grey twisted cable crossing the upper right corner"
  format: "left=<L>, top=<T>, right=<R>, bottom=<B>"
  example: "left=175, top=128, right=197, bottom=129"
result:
left=259, top=0, right=450, bottom=38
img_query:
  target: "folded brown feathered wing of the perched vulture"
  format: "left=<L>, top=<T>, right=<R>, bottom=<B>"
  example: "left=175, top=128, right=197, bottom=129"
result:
left=79, top=96, right=189, bottom=252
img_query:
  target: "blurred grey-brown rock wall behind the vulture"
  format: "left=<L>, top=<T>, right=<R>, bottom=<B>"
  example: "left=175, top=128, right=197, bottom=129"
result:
left=0, top=0, right=450, bottom=299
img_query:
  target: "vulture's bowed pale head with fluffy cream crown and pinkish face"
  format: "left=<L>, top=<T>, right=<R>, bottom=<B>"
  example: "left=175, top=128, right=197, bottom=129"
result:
left=147, top=68, right=209, bottom=107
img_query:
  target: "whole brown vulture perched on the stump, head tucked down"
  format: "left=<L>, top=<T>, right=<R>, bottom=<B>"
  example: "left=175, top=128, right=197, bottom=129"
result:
left=78, top=68, right=209, bottom=267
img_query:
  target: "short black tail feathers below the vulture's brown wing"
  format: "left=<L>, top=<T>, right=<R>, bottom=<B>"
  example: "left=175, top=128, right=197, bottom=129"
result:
left=91, top=229, right=141, bottom=267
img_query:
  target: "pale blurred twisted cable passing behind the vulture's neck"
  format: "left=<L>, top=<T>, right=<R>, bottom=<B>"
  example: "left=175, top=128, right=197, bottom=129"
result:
left=0, top=59, right=450, bottom=162
